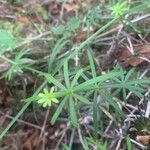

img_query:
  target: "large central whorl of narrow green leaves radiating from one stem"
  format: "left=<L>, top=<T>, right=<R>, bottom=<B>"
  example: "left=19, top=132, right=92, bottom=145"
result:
left=41, top=61, right=121, bottom=126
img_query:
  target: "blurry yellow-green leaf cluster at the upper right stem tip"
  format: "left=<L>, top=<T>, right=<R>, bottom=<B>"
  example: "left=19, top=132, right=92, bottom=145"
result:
left=110, top=1, right=129, bottom=18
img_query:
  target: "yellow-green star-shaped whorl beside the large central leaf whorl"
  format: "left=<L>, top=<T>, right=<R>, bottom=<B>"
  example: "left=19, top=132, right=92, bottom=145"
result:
left=37, top=87, right=59, bottom=107
